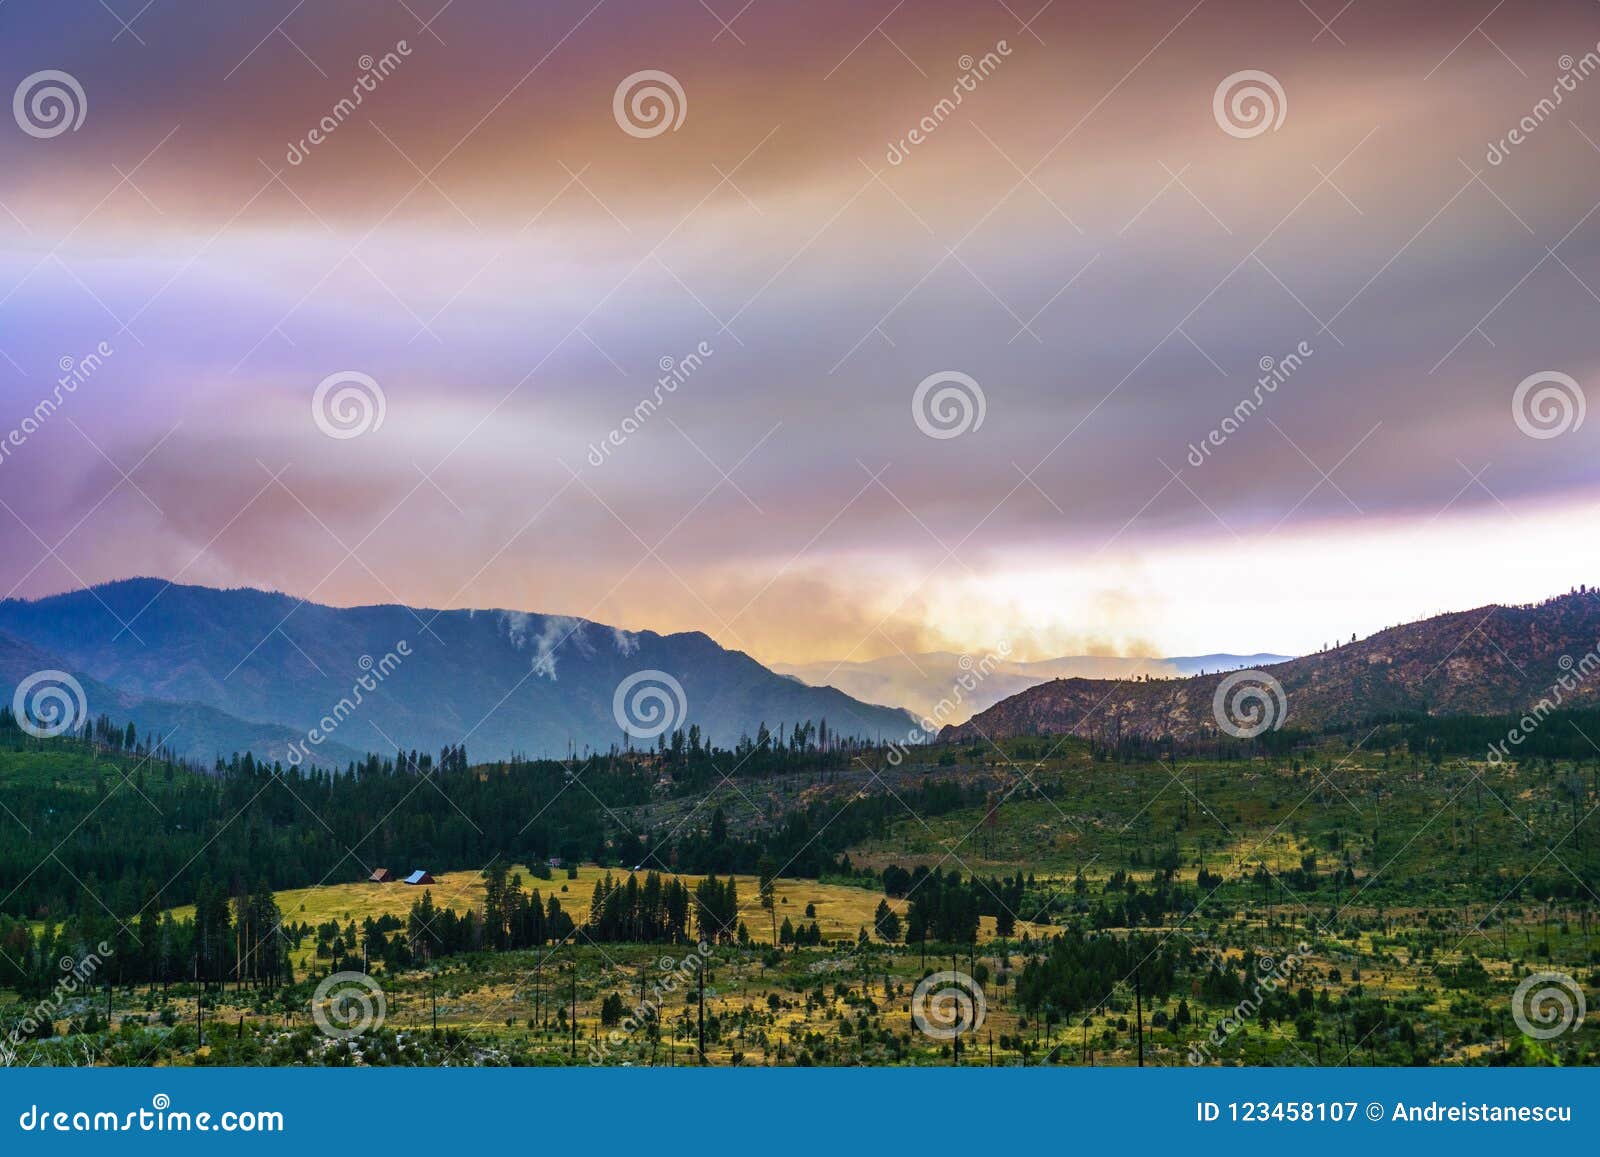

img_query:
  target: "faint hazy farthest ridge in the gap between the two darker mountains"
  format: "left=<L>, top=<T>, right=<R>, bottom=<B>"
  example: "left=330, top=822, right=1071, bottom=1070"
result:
left=771, top=651, right=1290, bottom=723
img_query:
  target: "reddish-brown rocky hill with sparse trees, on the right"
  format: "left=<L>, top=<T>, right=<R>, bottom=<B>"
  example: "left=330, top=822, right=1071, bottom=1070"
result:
left=941, top=589, right=1600, bottom=739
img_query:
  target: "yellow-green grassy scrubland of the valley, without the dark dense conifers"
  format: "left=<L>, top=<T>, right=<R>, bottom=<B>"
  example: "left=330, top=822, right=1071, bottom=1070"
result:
left=3, top=738, right=1600, bottom=1066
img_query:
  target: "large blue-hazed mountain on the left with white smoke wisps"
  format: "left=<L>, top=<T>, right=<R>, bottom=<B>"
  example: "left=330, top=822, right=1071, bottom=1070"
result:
left=0, top=579, right=912, bottom=767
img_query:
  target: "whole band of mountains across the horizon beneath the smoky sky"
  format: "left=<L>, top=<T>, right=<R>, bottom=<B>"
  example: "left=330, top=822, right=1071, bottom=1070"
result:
left=9, top=579, right=1600, bottom=767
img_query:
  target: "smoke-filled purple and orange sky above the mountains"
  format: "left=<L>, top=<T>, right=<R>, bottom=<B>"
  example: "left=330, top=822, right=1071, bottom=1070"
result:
left=0, top=0, right=1600, bottom=663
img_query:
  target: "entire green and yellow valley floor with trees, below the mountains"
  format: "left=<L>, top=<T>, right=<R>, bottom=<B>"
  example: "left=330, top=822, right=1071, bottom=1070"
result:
left=0, top=719, right=1600, bottom=1066
